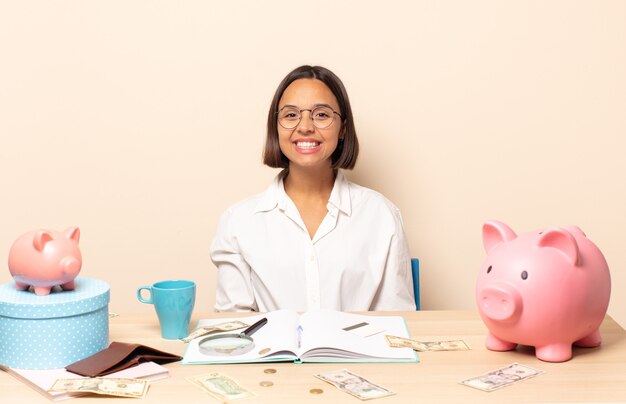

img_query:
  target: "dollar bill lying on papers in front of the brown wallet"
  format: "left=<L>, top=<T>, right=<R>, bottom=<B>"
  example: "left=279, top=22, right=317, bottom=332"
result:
left=50, top=377, right=150, bottom=398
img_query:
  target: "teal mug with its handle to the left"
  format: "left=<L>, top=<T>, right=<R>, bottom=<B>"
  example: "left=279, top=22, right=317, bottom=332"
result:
left=137, top=280, right=196, bottom=339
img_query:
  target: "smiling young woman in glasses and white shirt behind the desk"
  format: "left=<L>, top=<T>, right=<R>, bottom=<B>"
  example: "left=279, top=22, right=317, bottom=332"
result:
left=211, top=66, right=415, bottom=312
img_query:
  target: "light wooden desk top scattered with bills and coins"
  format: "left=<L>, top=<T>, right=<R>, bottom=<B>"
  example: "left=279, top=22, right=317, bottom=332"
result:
left=0, top=311, right=626, bottom=404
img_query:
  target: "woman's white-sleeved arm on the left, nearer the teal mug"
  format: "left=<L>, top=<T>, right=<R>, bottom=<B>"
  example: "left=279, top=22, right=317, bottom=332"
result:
left=211, top=209, right=258, bottom=311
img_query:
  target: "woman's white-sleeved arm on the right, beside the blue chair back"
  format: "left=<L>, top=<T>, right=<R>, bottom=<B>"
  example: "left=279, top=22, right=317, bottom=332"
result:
left=370, top=206, right=415, bottom=310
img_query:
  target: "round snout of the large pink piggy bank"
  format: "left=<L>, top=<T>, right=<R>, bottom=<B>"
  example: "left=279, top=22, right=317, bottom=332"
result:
left=478, top=284, right=523, bottom=321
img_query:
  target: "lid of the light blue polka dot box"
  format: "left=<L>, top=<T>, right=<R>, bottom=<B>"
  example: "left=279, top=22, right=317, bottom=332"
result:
left=0, top=277, right=109, bottom=319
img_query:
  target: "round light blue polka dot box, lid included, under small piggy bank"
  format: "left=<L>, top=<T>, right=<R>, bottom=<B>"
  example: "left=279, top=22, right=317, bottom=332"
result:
left=0, top=277, right=109, bottom=369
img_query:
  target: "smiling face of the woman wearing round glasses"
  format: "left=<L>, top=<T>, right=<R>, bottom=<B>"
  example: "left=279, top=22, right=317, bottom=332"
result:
left=277, top=79, right=342, bottom=172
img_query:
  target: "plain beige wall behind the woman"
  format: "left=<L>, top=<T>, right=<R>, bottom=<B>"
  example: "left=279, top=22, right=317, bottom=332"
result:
left=0, top=0, right=626, bottom=325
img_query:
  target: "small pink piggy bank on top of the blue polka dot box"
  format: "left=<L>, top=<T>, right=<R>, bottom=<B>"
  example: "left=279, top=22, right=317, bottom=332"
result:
left=9, top=227, right=82, bottom=295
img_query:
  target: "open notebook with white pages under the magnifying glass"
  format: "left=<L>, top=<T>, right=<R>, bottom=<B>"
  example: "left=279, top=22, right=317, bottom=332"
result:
left=182, top=310, right=418, bottom=364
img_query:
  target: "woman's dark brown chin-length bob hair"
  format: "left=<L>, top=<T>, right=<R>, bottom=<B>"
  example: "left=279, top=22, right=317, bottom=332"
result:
left=263, top=65, right=359, bottom=169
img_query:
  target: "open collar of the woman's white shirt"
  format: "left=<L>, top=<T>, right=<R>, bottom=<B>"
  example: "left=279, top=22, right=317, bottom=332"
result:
left=255, top=171, right=352, bottom=216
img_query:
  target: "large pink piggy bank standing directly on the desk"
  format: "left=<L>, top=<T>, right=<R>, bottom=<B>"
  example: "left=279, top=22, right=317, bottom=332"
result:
left=476, top=221, right=611, bottom=362
